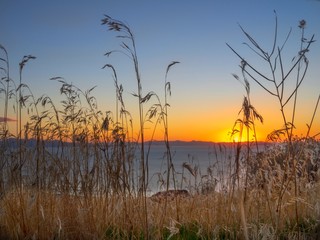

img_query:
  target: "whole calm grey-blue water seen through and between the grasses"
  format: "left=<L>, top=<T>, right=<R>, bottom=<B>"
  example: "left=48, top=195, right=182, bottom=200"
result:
left=4, top=141, right=320, bottom=197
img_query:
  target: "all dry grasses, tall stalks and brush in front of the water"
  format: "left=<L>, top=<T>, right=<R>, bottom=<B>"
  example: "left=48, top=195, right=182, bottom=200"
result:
left=0, top=16, right=320, bottom=239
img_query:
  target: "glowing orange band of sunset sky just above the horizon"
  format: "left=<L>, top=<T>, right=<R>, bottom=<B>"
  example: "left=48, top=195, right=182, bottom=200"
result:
left=3, top=97, right=320, bottom=142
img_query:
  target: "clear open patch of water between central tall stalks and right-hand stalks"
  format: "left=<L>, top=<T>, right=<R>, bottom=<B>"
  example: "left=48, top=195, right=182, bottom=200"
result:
left=142, top=142, right=234, bottom=192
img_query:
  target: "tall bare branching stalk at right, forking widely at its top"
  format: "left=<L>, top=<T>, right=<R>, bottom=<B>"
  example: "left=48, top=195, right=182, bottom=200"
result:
left=227, top=12, right=314, bottom=232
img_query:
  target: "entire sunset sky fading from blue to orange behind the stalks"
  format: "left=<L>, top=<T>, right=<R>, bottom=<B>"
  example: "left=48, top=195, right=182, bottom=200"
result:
left=0, top=0, right=320, bottom=141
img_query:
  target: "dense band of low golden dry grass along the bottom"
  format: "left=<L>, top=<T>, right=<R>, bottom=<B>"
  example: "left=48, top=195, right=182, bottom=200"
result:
left=0, top=181, right=320, bottom=239
